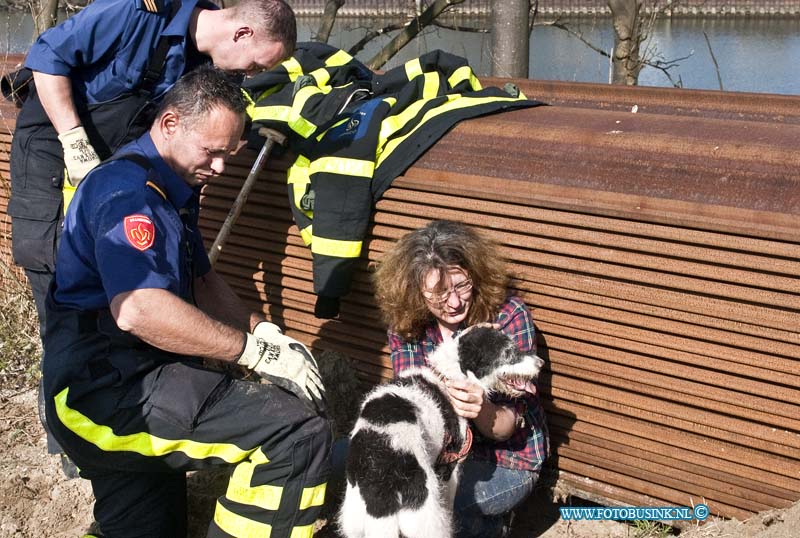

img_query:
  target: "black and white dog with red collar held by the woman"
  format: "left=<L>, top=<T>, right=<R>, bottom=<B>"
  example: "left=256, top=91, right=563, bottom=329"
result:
left=339, top=327, right=543, bottom=538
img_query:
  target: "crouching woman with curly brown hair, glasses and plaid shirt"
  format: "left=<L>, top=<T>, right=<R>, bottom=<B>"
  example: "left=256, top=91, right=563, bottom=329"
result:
left=375, top=220, right=549, bottom=538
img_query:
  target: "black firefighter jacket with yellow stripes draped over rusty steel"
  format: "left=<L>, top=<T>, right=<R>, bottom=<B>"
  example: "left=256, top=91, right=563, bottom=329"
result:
left=244, top=43, right=541, bottom=317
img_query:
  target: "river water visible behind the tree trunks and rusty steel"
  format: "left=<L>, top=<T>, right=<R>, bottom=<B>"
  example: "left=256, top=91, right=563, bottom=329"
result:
left=0, top=12, right=800, bottom=94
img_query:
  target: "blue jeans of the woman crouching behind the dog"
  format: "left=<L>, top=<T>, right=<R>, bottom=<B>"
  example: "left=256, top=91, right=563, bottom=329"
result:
left=454, top=458, right=539, bottom=538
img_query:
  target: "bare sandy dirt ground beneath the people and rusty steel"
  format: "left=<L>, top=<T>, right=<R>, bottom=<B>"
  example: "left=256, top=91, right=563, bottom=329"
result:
left=0, top=389, right=800, bottom=538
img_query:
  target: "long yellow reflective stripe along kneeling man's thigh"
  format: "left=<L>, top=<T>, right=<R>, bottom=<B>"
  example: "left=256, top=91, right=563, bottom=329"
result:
left=55, top=388, right=253, bottom=463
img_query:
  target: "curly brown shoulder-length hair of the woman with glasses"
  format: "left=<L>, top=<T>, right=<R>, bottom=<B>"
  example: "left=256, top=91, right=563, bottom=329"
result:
left=373, top=220, right=510, bottom=339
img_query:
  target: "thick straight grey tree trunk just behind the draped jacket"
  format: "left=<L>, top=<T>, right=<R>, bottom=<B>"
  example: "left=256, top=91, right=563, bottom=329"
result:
left=492, top=0, right=531, bottom=78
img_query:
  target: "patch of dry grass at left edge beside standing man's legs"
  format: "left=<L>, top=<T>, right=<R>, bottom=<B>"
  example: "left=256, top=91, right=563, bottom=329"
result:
left=0, top=260, right=42, bottom=390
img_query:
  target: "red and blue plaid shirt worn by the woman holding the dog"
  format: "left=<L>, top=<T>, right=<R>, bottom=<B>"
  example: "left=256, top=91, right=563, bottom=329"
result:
left=389, top=296, right=550, bottom=471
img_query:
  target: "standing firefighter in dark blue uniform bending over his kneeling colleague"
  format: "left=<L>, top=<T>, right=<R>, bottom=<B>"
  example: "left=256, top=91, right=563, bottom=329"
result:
left=8, top=0, right=296, bottom=464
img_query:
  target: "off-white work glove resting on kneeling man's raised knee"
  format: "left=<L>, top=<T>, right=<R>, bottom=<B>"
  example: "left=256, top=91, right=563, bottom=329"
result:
left=236, top=321, right=325, bottom=411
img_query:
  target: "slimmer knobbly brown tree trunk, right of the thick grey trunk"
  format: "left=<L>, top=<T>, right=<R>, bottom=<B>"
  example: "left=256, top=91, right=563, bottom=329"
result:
left=607, top=0, right=644, bottom=86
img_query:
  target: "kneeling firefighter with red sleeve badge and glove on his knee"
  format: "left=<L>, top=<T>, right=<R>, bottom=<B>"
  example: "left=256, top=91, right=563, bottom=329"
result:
left=43, top=67, right=330, bottom=538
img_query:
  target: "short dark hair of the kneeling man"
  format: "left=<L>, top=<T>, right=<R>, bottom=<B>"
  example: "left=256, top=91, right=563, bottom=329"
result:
left=156, top=65, right=247, bottom=125
